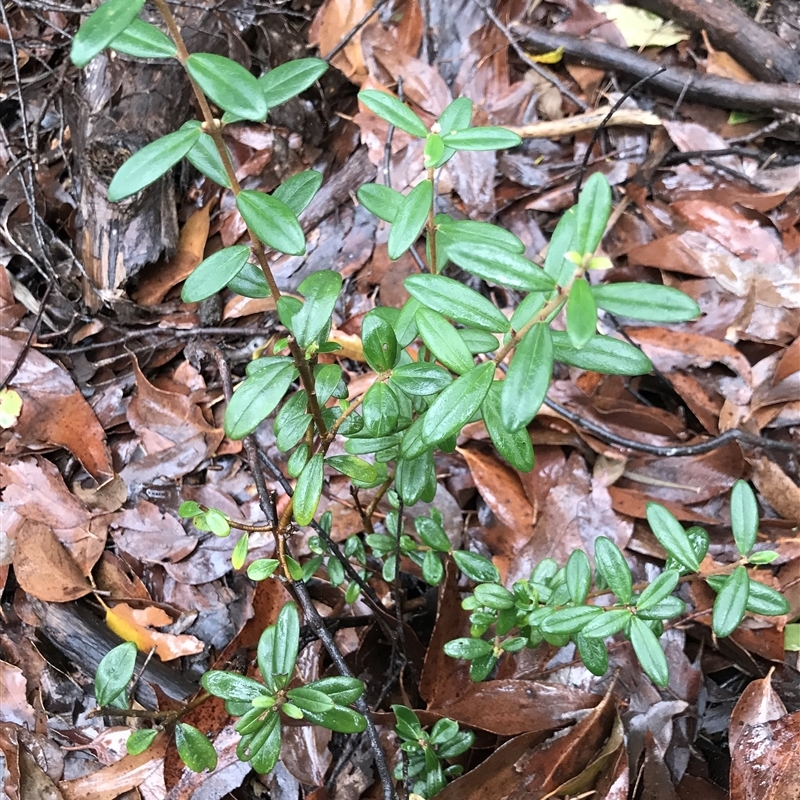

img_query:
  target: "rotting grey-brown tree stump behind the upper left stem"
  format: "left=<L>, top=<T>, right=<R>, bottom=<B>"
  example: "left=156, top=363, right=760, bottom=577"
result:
left=70, top=0, right=227, bottom=307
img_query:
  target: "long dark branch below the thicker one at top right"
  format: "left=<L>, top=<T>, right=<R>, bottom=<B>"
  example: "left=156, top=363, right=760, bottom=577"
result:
left=512, top=24, right=800, bottom=113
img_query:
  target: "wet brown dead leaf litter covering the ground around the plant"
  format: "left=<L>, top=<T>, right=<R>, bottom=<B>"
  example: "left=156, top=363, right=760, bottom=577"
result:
left=0, top=0, right=800, bottom=800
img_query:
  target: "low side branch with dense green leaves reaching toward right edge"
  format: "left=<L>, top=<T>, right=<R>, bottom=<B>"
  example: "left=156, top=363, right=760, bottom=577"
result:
left=445, top=481, right=789, bottom=686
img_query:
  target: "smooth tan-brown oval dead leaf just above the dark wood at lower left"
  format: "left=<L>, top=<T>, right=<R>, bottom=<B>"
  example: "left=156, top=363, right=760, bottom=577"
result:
left=14, top=519, right=92, bottom=603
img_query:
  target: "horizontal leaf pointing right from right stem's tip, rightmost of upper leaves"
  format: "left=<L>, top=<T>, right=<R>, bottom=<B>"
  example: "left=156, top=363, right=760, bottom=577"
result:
left=592, top=283, right=702, bottom=322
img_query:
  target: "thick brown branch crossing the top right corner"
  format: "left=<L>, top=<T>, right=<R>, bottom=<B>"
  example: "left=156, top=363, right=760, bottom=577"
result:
left=635, top=0, right=800, bottom=83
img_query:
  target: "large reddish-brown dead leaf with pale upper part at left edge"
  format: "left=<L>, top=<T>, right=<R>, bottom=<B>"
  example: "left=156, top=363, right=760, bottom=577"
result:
left=0, top=336, right=114, bottom=483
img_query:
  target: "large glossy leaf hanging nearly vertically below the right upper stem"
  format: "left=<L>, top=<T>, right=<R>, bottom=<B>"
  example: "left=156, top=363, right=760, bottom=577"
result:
left=500, top=322, right=554, bottom=433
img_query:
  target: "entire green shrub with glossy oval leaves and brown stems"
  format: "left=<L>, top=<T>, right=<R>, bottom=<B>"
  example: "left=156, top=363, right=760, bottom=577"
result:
left=71, top=0, right=788, bottom=797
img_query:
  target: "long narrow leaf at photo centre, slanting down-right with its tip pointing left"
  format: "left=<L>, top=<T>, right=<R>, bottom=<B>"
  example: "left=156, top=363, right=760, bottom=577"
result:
left=403, top=275, right=511, bottom=333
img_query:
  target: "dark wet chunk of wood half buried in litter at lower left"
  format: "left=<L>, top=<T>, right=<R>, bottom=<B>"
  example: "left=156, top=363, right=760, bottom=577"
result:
left=29, top=597, right=198, bottom=709
